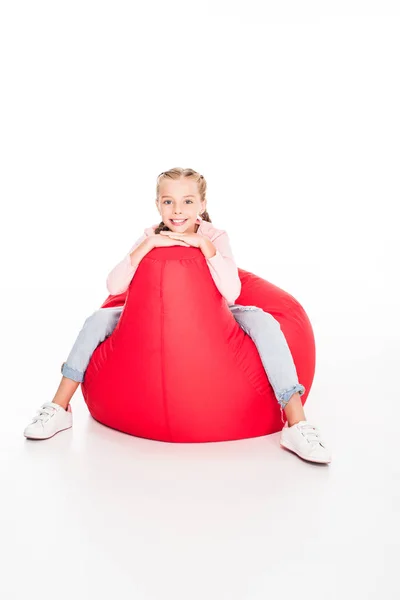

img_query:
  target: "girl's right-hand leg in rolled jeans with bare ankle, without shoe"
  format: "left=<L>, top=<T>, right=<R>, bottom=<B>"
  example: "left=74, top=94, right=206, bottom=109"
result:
left=229, top=304, right=305, bottom=426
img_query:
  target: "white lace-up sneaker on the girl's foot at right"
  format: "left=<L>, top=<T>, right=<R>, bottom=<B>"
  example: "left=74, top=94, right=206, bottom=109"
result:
left=280, top=421, right=332, bottom=463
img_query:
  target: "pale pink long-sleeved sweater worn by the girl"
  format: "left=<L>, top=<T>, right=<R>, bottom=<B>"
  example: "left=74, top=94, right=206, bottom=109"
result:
left=107, top=217, right=241, bottom=304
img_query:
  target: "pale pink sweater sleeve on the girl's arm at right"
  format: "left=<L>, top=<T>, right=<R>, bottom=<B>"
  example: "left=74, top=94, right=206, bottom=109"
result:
left=206, top=231, right=242, bottom=304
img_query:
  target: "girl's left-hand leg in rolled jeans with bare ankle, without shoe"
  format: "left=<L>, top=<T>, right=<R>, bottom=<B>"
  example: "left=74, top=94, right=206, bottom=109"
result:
left=52, top=306, right=123, bottom=409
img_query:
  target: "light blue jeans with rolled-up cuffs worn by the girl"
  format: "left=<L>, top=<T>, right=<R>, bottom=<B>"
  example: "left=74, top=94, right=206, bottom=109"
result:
left=61, top=304, right=306, bottom=422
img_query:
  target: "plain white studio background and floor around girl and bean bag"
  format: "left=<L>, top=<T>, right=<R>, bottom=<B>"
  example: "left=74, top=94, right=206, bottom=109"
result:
left=0, top=0, right=400, bottom=600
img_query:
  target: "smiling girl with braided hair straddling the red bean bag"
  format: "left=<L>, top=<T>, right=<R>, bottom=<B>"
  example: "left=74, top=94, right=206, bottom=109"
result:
left=24, top=168, right=331, bottom=463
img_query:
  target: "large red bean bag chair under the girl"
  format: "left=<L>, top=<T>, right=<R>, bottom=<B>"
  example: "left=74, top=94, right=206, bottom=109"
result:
left=81, top=246, right=315, bottom=442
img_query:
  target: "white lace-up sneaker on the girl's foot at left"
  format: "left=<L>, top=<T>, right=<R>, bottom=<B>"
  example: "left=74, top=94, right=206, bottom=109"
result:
left=24, top=402, right=72, bottom=440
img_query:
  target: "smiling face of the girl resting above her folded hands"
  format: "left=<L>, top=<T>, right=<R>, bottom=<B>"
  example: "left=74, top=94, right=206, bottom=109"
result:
left=156, top=178, right=206, bottom=233
